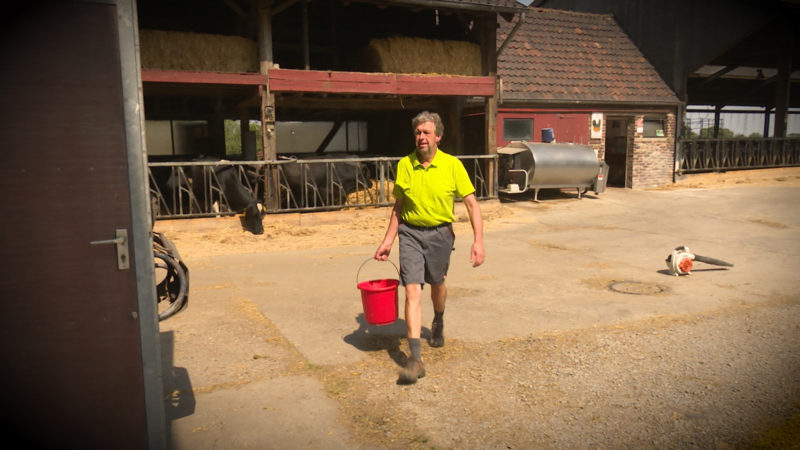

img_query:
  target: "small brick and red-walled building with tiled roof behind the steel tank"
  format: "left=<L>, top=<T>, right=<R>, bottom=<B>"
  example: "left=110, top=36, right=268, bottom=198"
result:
left=496, top=8, right=681, bottom=189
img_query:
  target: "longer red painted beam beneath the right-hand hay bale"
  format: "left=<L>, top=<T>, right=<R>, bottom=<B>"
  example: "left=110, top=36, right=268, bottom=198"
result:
left=269, top=69, right=495, bottom=97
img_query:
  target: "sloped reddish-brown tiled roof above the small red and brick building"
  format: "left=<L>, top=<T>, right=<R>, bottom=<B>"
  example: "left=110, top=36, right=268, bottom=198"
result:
left=497, top=8, right=679, bottom=105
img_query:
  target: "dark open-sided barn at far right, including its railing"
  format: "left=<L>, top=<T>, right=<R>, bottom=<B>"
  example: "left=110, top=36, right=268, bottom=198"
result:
left=534, top=0, right=800, bottom=177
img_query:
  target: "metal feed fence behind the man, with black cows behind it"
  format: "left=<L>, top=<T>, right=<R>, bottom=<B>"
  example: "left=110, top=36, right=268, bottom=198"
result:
left=148, top=155, right=497, bottom=219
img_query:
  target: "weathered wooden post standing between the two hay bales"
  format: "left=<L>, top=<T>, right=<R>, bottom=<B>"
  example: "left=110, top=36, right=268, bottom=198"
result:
left=258, top=0, right=280, bottom=210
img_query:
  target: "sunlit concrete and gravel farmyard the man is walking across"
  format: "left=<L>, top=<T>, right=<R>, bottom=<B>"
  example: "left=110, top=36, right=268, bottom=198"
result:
left=156, top=169, right=800, bottom=449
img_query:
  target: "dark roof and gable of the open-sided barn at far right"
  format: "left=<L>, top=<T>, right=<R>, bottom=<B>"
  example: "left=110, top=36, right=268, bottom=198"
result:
left=534, top=0, right=800, bottom=108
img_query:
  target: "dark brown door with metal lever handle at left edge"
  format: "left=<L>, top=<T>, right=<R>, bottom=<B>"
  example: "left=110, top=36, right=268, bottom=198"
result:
left=0, top=1, right=163, bottom=449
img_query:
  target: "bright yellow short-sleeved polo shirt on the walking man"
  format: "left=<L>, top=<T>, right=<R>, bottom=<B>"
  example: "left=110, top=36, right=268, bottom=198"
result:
left=394, top=149, right=475, bottom=227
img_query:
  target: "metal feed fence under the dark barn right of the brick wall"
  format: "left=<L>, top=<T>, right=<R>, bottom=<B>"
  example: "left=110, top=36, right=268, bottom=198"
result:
left=676, top=138, right=800, bottom=174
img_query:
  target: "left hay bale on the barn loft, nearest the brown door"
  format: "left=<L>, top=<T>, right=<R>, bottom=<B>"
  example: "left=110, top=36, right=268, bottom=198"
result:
left=139, top=30, right=258, bottom=72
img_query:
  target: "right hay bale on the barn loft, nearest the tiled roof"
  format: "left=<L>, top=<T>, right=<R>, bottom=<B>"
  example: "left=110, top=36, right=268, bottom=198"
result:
left=361, top=37, right=482, bottom=76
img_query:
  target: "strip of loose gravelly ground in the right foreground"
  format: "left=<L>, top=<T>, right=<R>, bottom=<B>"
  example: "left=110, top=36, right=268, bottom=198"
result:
left=322, top=304, right=800, bottom=448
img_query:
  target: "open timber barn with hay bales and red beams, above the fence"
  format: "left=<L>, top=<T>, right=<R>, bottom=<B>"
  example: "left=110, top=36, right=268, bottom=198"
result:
left=138, top=0, right=525, bottom=211
